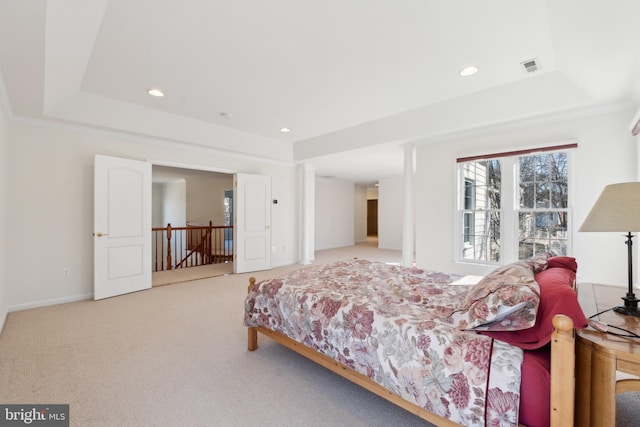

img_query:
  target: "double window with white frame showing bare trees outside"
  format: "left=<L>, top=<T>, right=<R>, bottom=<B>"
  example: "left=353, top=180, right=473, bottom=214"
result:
left=458, top=144, right=577, bottom=263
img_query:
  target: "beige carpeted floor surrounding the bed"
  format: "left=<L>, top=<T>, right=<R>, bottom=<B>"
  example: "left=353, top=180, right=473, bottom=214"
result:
left=0, top=244, right=640, bottom=427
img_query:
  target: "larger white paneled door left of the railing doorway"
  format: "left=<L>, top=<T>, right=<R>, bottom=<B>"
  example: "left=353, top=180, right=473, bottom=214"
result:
left=93, top=155, right=151, bottom=299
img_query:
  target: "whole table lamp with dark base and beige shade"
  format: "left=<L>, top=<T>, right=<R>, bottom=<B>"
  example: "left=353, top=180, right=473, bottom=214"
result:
left=579, top=182, right=640, bottom=317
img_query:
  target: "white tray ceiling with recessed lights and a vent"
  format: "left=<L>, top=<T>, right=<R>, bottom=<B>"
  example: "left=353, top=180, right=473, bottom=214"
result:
left=0, top=0, right=640, bottom=181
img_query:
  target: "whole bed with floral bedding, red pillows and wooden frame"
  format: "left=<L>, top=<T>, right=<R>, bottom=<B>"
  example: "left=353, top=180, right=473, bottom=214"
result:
left=244, top=254, right=587, bottom=427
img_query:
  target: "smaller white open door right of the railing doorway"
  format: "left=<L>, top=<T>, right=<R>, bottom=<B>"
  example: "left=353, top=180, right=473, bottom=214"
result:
left=233, top=174, right=271, bottom=273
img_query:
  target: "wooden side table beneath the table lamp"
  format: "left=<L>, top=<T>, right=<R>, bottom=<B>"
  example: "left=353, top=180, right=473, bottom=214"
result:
left=575, top=283, right=640, bottom=427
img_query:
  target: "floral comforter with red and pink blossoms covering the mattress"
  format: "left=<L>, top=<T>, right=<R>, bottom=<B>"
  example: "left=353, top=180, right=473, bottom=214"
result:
left=245, top=259, right=522, bottom=426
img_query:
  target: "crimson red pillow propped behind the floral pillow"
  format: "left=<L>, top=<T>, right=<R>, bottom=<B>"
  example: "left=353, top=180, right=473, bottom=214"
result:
left=479, top=268, right=589, bottom=350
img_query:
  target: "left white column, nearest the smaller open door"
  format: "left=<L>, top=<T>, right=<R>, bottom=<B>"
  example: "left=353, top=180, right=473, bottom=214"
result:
left=299, top=163, right=316, bottom=264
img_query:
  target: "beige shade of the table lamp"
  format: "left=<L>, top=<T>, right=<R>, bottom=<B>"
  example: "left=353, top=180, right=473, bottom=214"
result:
left=579, top=182, right=640, bottom=232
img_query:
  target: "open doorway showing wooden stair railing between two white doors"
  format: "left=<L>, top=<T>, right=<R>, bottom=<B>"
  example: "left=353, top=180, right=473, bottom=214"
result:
left=152, top=165, right=234, bottom=286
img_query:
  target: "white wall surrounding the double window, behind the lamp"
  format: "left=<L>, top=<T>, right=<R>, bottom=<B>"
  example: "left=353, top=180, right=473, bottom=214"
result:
left=415, top=110, right=638, bottom=286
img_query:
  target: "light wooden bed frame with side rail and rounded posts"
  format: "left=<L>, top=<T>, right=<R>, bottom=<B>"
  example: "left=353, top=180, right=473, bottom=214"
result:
left=247, top=277, right=575, bottom=427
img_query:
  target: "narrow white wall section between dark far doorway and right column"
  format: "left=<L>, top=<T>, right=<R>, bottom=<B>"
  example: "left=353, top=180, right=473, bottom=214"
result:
left=378, top=178, right=404, bottom=250
